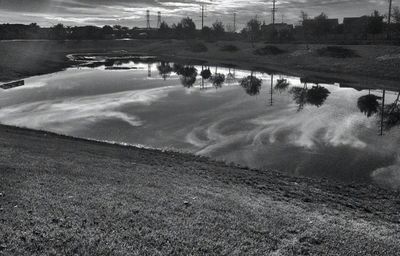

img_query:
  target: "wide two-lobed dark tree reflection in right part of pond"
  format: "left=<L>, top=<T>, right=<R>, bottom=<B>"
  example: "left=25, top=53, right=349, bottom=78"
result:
left=289, top=83, right=330, bottom=111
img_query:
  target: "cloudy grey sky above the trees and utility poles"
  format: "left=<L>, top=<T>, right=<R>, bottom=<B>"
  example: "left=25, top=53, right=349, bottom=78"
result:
left=0, top=0, right=394, bottom=28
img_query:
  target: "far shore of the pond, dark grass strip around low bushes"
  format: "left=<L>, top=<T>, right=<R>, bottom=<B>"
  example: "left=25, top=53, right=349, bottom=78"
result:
left=0, top=40, right=400, bottom=88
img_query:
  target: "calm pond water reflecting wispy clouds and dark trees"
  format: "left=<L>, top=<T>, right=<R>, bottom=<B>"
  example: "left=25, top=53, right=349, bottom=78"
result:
left=0, top=59, right=400, bottom=188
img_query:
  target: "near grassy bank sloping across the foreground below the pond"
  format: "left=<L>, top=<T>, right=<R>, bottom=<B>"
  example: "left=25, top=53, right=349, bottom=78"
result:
left=0, top=126, right=400, bottom=255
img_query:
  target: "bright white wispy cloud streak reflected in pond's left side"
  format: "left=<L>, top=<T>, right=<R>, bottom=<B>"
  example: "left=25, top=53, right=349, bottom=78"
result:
left=0, top=86, right=172, bottom=134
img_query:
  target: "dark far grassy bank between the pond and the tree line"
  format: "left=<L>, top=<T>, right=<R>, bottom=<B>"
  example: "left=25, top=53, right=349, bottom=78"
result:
left=0, top=40, right=400, bottom=84
